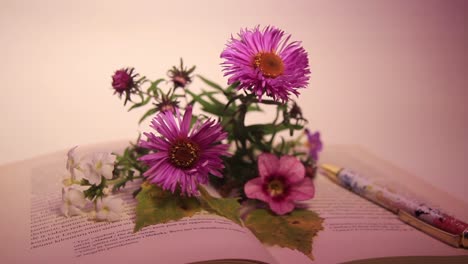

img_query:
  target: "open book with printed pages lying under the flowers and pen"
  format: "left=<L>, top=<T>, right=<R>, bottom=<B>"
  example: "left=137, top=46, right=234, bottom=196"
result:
left=0, top=142, right=468, bottom=264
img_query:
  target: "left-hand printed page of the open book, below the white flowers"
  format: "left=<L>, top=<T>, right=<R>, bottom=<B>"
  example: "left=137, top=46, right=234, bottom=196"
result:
left=0, top=142, right=276, bottom=264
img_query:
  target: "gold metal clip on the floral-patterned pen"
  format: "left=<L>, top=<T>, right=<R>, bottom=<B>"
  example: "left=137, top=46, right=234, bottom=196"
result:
left=398, top=210, right=468, bottom=248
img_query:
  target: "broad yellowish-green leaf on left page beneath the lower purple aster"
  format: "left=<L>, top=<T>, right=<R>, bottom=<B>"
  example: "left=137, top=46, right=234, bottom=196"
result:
left=134, top=182, right=201, bottom=232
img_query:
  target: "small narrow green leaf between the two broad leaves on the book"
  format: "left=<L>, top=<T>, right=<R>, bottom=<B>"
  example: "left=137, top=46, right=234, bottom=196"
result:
left=198, top=186, right=242, bottom=225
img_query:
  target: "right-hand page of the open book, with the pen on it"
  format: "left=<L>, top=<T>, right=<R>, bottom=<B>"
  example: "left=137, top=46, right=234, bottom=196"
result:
left=270, top=146, right=468, bottom=264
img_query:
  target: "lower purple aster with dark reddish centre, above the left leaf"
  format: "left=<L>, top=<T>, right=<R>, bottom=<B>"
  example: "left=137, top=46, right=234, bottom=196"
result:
left=139, top=106, right=230, bottom=196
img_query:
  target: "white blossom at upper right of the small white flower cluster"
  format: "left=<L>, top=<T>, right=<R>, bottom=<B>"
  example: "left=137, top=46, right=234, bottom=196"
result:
left=84, top=153, right=116, bottom=185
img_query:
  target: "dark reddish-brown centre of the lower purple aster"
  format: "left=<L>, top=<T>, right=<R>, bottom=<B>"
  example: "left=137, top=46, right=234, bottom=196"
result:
left=169, top=140, right=200, bottom=169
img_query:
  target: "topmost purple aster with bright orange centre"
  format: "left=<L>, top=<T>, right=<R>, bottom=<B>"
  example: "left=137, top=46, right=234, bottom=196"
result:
left=221, top=26, right=310, bottom=102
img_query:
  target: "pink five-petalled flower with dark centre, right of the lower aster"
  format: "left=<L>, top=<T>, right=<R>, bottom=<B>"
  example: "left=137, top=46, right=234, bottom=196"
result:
left=244, top=153, right=315, bottom=215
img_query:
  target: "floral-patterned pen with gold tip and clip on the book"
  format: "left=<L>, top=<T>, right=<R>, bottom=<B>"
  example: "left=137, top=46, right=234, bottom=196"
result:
left=320, top=164, right=468, bottom=248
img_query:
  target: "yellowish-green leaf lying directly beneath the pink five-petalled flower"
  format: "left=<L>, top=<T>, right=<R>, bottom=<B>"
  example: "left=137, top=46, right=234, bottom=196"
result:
left=244, top=209, right=323, bottom=260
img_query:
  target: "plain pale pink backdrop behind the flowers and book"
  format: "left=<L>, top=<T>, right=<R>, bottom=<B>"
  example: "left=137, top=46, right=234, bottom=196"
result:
left=0, top=0, right=468, bottom=201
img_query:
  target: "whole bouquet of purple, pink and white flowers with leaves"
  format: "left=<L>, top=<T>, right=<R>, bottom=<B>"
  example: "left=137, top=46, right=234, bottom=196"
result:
left=62, top=26, right=323, bottom=257
